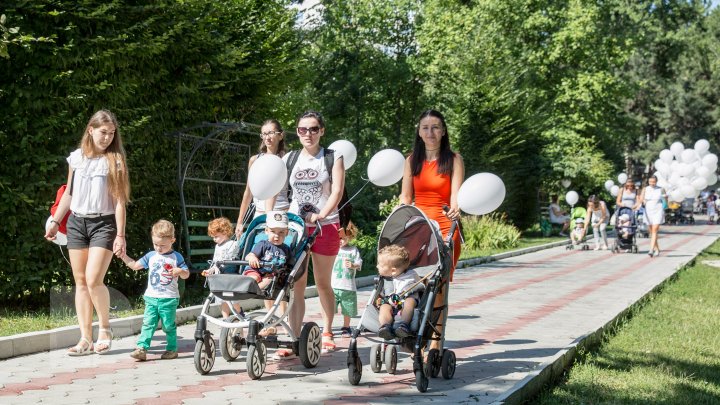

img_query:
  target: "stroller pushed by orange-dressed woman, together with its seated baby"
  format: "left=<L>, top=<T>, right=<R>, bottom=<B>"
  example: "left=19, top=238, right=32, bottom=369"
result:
left=347, top=205, right=457, bottom=392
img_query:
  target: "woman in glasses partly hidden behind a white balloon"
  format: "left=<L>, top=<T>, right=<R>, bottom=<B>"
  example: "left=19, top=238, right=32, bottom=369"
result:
left=235, top=119, right=290, bottom=240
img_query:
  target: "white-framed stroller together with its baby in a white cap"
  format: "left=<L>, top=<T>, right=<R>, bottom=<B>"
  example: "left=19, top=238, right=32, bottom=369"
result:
left=194, top=212, right=321, bottom=379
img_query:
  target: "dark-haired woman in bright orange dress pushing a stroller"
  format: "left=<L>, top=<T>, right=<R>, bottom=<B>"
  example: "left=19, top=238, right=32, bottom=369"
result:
left=400, top=110, right=465, bottom=349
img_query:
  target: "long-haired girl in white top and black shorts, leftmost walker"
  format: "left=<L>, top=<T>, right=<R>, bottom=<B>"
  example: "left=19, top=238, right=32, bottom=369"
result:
left=45, top=110, right=130, bottom=356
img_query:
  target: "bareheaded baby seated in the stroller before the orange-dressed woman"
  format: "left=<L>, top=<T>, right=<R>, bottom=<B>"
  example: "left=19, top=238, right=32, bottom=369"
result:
left=375, top=245, right=420, bottom=340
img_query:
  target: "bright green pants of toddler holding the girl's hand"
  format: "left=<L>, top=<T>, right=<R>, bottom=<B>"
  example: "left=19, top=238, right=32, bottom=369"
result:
left=137, top=295, right=180, bottom=352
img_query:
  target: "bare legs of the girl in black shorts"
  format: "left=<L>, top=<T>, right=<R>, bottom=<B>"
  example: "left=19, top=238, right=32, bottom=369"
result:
left=69, top=247, right=112, bottom=349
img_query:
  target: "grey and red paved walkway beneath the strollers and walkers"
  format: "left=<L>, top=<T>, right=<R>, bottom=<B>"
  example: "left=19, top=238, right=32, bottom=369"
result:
left=0, top=220, right=720, bottom=405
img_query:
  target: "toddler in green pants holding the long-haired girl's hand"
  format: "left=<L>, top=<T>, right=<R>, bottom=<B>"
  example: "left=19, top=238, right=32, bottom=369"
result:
left=120, top=219, right=190, bottom=361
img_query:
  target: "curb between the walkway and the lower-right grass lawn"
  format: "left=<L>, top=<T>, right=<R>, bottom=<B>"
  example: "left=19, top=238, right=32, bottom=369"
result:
left=493, top=258, right=704, bottom=405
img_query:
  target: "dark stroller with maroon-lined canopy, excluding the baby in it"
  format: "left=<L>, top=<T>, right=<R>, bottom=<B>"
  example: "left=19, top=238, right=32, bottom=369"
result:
left=347, top=205, right=456, bottom=392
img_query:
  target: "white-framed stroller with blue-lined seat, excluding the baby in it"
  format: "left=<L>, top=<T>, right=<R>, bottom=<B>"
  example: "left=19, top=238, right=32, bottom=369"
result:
left=194, top=213, right=321, bottom=380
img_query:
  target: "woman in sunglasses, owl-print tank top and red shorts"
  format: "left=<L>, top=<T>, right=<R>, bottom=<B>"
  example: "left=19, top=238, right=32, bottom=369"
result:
left=275, top=111, right=345, bottom=359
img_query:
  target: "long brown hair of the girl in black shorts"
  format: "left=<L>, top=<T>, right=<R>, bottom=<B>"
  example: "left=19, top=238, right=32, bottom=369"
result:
left=80, top=110, right=130, bottom=203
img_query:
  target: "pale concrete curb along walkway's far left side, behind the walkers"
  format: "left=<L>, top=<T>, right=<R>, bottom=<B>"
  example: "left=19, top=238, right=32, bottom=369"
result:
left=0, top=235, right=570, bottom=359
